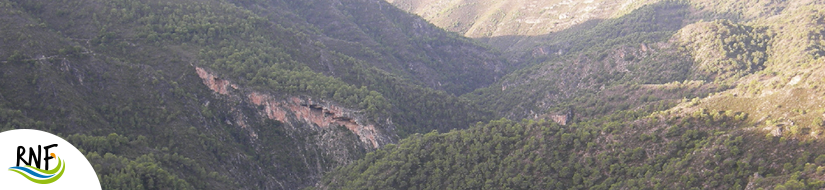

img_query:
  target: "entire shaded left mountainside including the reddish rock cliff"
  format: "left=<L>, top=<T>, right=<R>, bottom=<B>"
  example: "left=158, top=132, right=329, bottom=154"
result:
left=0, top=0, right=507, bottom=189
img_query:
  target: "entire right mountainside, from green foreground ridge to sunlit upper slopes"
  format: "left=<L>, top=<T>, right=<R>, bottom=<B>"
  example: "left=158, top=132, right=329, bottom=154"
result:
left=316, top=1, right=825, bottom=189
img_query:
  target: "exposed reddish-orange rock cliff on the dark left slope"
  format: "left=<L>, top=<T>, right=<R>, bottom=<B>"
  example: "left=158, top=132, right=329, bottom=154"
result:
left=195, top=67, right=397, bottom=178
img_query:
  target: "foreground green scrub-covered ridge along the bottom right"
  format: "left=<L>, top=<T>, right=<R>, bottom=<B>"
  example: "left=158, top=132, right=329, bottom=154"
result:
left=321, top=110, right=825, bottom=189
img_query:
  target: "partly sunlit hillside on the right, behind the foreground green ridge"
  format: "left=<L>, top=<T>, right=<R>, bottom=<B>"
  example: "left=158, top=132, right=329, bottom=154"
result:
left=464, top=1, right=814, bottom=119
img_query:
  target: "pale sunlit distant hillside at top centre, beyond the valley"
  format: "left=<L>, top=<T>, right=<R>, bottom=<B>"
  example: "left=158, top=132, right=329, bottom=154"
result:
left=389, top=0, right=650, bottom=50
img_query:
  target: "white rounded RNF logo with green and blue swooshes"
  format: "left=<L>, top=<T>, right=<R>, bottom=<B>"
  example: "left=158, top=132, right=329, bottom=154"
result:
left=0, top=129, right=101, bottom=190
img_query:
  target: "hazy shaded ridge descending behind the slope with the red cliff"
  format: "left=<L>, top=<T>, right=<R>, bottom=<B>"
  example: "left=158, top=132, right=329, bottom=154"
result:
left=240, top=0, right=507, bottom=95
